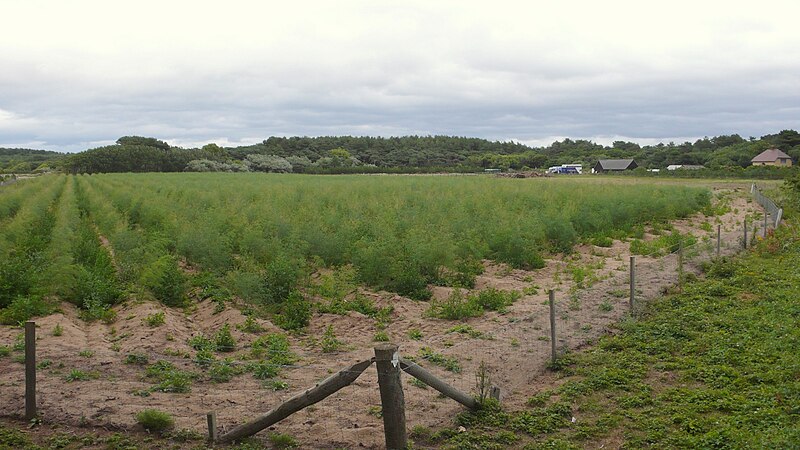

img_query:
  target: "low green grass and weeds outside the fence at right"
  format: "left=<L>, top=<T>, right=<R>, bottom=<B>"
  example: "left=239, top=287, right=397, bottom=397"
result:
left=428, top=223, right=800, bottom=449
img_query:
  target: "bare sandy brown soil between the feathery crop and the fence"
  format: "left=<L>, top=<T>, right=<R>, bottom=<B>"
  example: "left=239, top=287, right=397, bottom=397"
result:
left=0, top=185, right=758, bottom=448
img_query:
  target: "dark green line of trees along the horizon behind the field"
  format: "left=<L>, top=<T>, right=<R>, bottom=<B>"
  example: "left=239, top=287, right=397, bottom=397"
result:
left=15, top=130, right=800, bottom=173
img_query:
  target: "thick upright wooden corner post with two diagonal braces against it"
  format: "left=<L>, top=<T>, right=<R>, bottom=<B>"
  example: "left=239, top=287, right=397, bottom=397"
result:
left=375, top=343, right=408, bottom=450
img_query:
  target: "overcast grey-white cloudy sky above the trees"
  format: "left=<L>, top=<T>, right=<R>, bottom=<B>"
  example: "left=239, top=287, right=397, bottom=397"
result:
left=0, top=0, right=800, bottom=151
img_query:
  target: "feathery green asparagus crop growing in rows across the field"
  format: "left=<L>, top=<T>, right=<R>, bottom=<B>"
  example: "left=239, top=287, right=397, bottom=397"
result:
left=0, top=174, right=710, bottom=329
